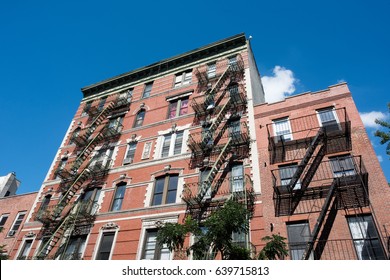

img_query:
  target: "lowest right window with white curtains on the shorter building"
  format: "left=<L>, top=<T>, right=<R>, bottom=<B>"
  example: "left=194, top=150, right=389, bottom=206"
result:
left=347, top=215, right=385, bottom=260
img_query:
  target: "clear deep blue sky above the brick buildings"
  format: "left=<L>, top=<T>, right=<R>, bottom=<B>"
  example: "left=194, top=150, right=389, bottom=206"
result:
left=0, top=0, right=390, bottom=194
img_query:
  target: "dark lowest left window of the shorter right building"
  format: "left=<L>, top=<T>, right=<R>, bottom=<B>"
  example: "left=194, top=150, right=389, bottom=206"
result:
left=287, top=222, right=310, bottom=260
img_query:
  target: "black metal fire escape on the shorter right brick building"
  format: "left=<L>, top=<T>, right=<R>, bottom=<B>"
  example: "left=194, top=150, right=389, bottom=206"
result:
left=267, top=108, right=386, bottom=260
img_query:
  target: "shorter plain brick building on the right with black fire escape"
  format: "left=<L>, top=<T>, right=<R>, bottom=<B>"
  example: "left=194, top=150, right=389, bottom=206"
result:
left=255, top=83, right=390, bottom=260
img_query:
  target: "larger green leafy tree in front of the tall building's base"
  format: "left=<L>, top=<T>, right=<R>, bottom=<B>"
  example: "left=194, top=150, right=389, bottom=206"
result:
left=157, top=200, right=250, bottom=259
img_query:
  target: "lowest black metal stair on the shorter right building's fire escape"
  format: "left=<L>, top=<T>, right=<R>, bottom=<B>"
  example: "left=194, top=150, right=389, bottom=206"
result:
left=302, top=178, right=339, bottom=260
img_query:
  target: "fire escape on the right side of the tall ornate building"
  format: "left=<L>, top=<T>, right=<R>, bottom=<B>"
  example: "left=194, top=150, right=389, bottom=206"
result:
left=182, top=56, right=254, bottom=252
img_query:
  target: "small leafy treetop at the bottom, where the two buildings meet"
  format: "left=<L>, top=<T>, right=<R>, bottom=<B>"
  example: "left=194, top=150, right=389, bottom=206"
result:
left=258, top=234, right=288, bottom=260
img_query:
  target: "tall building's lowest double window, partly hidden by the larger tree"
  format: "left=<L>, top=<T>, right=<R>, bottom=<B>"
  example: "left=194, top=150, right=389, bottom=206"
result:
left=142, top=229, right=171, bottom=260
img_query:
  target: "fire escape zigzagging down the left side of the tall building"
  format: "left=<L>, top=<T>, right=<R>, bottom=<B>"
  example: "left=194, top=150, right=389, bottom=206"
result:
left=36, top=94, right=130, bottom=259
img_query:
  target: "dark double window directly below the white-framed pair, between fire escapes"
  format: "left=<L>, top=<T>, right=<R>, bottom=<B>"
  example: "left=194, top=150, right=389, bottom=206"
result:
left=152, top=174, right=179, bottom=205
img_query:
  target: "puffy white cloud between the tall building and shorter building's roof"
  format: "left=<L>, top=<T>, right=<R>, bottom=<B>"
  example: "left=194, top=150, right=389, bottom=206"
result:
left=261, top=65, right=297, bottom=103
